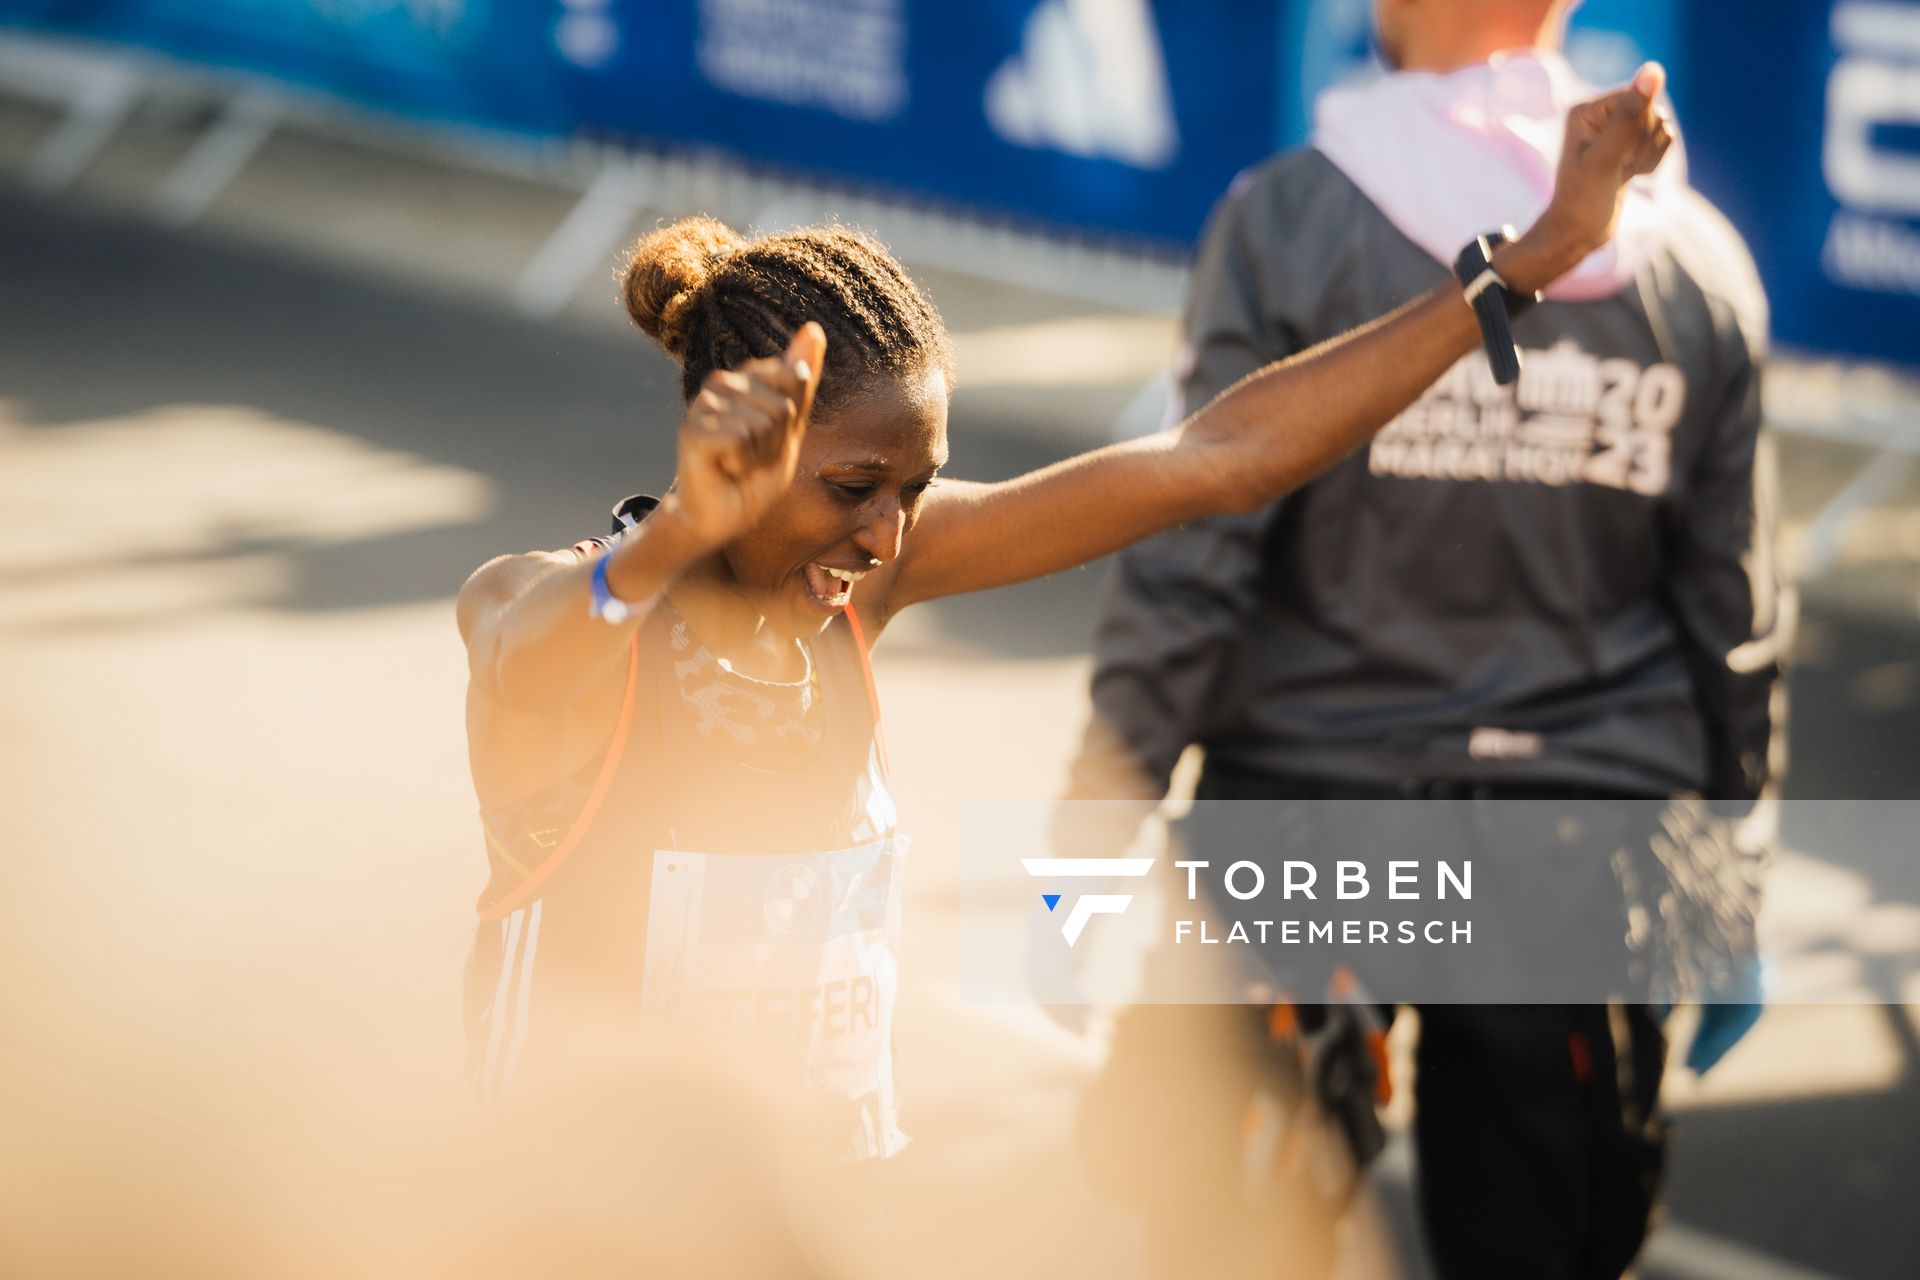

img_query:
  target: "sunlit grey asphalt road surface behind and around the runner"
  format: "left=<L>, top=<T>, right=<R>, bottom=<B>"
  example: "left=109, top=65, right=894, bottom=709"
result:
left=0, top=188, right=1920, bottom=1280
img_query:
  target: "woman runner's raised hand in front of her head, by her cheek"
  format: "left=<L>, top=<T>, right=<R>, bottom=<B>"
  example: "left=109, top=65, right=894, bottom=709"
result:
left=668, top=320, right=828, bottom=547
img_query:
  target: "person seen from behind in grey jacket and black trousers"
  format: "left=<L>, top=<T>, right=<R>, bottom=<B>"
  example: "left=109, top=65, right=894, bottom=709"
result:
left=1069, top=0, right=1793, bottom=1280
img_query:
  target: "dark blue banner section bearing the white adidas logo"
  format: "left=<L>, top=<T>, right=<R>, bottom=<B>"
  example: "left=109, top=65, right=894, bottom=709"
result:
left=566, top=0, right=1281, bottom=248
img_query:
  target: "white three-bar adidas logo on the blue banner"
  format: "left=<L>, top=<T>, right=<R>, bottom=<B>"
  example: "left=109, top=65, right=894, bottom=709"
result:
left=985, top=0, right=1181, bottom=169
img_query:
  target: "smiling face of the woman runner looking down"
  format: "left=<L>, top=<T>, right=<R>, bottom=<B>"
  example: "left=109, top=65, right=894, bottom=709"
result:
left=724, top=370, right=947, bottom=635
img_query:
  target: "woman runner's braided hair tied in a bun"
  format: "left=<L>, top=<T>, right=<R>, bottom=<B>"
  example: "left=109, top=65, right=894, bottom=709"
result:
left=620, top=217, right=952, bottom=411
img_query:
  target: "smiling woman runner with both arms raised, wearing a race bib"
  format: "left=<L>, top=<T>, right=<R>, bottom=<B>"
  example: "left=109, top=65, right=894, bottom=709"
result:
left=459, top=67, right=1668, bottom=1157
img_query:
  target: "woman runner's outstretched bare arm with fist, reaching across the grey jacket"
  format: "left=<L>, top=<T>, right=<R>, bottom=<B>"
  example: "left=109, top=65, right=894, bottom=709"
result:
left=887, top=63, right=1670, bottom=612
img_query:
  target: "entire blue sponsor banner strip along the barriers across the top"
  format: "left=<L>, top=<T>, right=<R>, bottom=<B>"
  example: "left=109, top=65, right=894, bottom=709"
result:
left=0, top=0, right=1920, bottom=365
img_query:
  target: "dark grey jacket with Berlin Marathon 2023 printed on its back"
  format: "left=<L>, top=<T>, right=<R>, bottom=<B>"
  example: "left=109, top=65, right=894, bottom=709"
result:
left=1073, top=150, right=1791, bottom=798
